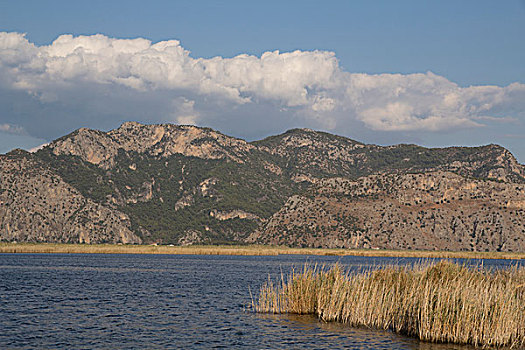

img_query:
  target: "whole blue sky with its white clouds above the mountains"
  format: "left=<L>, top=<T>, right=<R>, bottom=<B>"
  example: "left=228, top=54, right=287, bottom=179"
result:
left=0, top=0, right=525, bottom=163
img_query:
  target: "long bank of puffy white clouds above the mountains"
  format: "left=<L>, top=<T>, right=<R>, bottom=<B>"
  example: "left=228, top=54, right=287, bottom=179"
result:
left=0, top=32, right=525, bottom=144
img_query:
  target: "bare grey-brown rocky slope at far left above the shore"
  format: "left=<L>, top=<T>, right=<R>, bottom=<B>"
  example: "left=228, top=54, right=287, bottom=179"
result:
left=0, top=151, right=141, bottom=243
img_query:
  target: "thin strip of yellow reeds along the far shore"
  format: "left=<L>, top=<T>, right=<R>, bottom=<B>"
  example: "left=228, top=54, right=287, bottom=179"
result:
left=0, top=243, right=525, bottom=259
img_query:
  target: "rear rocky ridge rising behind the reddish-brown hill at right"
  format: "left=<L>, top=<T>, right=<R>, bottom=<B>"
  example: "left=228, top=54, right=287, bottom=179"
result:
left=254, top=129, right=525, bottom=182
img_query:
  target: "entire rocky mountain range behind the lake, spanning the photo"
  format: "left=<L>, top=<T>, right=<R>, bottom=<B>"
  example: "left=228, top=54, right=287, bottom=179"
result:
left=0, top=122, right=525, bottom=251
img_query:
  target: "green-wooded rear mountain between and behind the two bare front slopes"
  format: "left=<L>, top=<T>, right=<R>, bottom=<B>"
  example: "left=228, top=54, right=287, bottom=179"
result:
left=19, top=123, right=525, bottom=244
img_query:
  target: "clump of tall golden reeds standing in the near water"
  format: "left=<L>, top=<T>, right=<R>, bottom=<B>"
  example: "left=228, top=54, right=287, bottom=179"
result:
left=252, top=261, right=525, bottom=348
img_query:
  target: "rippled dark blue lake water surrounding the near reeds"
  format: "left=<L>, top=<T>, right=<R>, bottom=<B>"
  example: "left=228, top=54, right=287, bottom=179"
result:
left=0, top=254, right=518, bottom=350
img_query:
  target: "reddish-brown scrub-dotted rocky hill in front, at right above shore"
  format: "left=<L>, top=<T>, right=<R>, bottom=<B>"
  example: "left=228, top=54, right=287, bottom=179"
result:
left=249, top=171, right=525, bottom=251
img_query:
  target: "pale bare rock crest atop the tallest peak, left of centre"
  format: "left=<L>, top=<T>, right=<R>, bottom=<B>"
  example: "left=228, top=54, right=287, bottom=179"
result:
left=49, top=122, right=255, bottom=169
